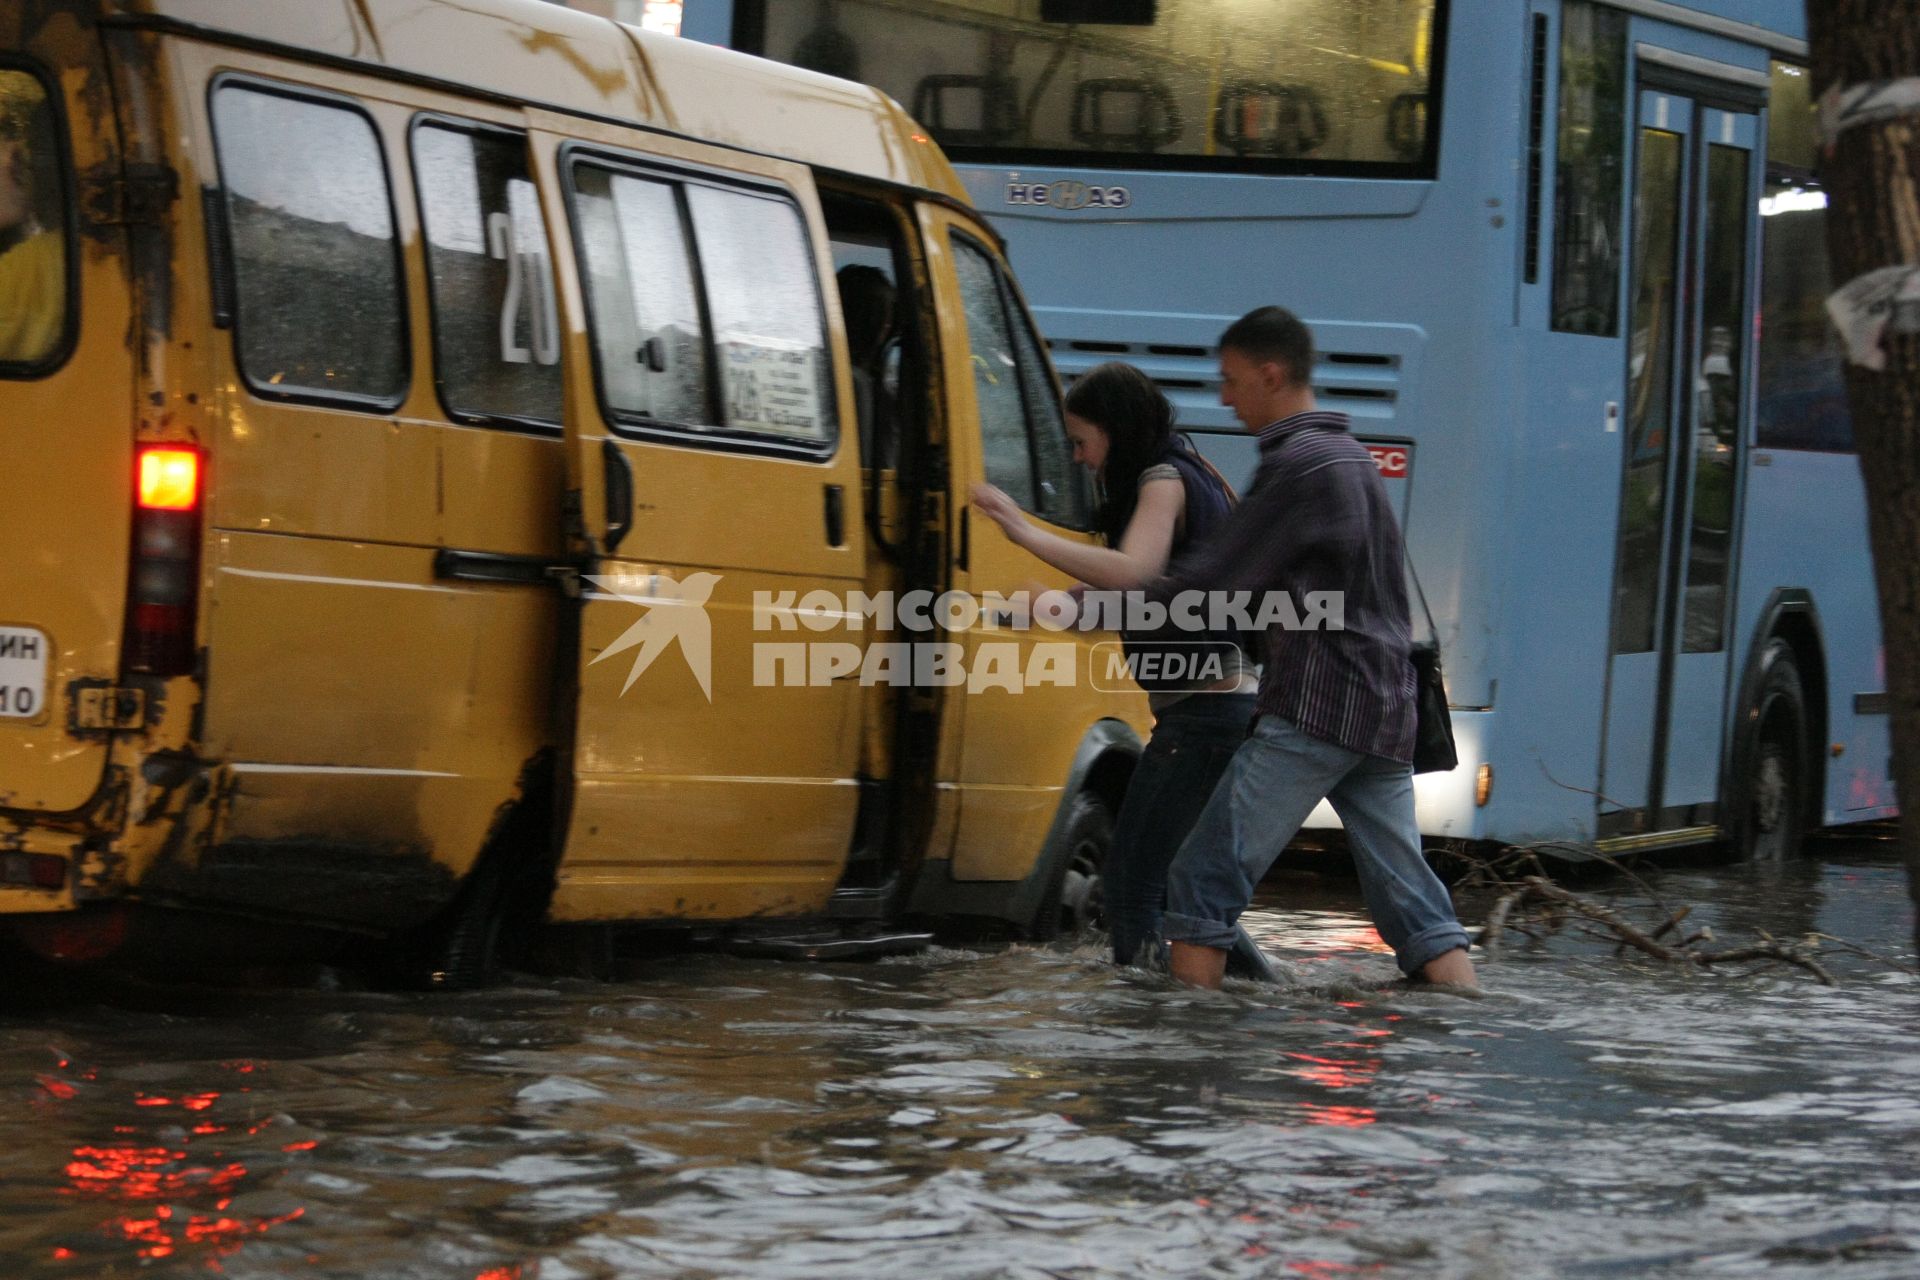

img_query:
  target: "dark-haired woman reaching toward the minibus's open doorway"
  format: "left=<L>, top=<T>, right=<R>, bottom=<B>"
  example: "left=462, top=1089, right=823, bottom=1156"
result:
left=972, top=363, right=1258, bottom=963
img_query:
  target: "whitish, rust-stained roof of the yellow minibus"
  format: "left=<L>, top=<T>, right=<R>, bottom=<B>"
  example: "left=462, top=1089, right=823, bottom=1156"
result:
left=102, top=0, right=966, bottom=201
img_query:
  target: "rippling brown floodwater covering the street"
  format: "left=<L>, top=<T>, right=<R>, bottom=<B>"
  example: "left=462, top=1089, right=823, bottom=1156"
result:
left=0, top=842, right=1920, bottom=1280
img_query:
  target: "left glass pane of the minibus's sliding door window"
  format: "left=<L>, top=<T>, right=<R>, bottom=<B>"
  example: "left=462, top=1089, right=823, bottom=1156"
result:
left=574, top=165, right=714, bottom=426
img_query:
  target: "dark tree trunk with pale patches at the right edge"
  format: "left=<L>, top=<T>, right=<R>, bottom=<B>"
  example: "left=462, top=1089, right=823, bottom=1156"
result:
left=1807, top=0, right=1920, bottom=946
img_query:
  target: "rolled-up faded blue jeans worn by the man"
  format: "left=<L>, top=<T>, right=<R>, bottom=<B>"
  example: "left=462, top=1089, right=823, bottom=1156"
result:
left=1162, top=716, right=1467, bottom=975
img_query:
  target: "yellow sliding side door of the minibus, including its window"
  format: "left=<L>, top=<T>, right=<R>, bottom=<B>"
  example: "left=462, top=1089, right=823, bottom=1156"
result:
left=530, top=111, right=866, bottom=921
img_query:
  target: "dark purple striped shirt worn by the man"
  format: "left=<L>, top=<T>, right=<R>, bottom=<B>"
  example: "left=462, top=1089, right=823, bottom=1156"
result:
left=1146, top=411, right=1413, bottom=762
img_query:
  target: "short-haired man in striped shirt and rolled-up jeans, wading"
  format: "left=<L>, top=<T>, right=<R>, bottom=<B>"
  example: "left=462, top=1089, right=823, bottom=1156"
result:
left=1144, top=307, right=1475, bottom=986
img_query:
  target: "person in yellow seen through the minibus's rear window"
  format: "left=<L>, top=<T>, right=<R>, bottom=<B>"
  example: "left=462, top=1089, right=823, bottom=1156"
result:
left=0, top=123, right=67, bottom=365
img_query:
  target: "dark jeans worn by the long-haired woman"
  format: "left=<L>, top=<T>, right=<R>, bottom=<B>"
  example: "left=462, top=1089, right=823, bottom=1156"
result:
left=1100, top=693, right=1254, bottom=965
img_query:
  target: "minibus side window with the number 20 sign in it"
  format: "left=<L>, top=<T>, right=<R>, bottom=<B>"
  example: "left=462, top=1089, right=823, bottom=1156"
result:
left=413, top=123, right=561, bottom=424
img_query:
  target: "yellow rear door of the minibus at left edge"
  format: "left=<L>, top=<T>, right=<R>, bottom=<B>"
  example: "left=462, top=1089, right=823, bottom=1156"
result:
left=0, top=25, right=134, bottom=812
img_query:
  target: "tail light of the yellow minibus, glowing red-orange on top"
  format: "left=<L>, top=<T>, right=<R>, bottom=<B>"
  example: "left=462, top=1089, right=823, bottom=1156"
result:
left=125, top=445, right=202, bottom=676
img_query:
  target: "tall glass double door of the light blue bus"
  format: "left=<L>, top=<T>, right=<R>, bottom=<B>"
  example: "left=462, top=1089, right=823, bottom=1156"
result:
left=1599, top=88, right=1759, bottom=837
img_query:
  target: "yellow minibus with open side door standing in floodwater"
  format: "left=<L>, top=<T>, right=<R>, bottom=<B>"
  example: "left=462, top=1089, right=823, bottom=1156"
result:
left=0, top=0, right=1144, bottom=983
